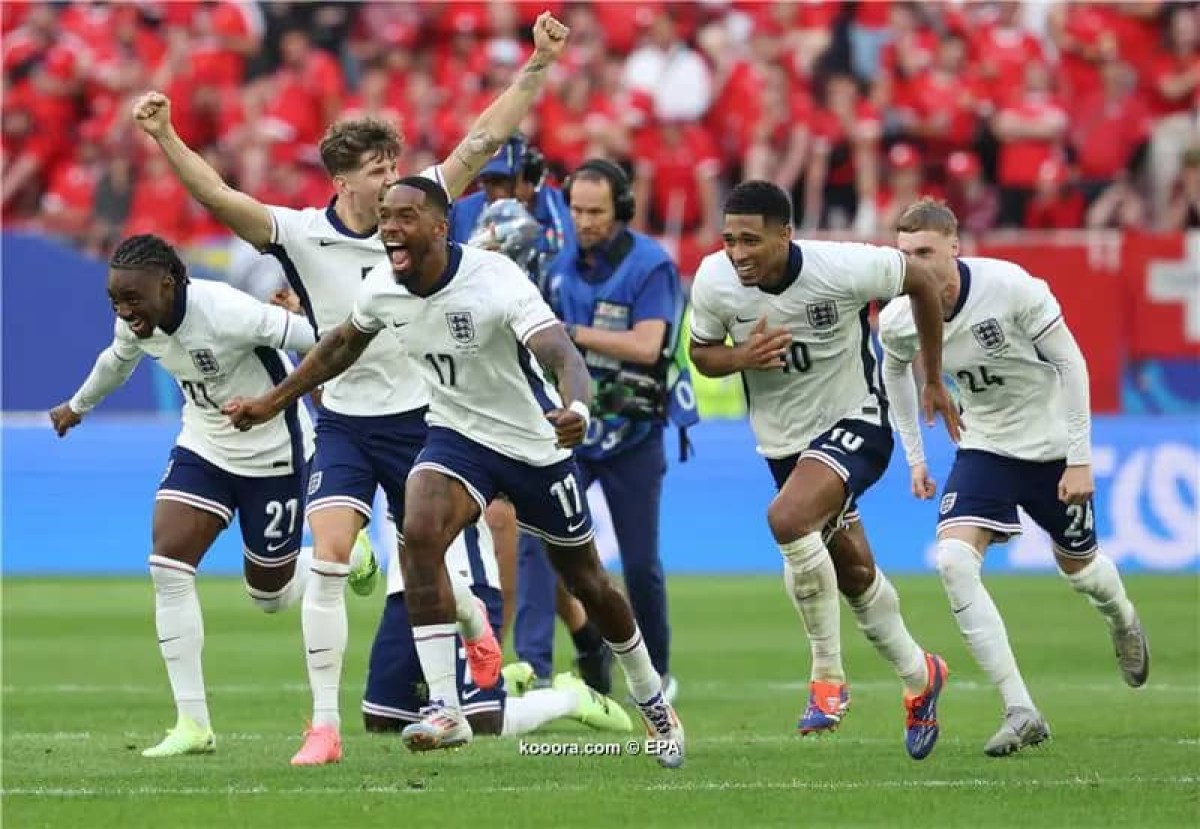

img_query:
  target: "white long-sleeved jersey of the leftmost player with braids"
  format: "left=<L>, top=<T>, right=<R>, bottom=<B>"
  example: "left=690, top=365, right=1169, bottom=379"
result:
left=71, top=280, right=313, bottom=477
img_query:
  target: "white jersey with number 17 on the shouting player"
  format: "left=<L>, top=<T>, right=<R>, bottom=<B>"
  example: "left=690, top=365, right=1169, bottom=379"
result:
left=352, top=244, right=571, bottom=467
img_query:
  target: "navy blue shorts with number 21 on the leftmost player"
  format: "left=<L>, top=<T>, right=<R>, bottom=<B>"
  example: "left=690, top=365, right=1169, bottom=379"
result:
left=155, top=446, right=307, bottom=567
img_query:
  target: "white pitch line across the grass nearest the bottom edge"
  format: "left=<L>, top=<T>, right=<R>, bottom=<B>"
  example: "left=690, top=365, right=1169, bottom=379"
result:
left=0, top=776, right=1200, bottom=798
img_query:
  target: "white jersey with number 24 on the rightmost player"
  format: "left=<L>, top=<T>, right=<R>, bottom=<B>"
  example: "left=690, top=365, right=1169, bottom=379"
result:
left=880, top=257, right=1067, bottom=461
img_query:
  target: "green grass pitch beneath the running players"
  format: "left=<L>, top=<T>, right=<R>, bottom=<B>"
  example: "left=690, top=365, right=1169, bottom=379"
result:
left=2, top=575, right=1200, bottom=829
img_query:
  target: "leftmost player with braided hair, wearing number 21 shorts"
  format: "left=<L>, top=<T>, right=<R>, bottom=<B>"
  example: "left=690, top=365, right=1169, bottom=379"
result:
left=50, top=235, right=328, bottom=757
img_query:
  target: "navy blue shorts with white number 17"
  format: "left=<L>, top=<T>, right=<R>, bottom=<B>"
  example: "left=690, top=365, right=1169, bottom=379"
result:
left=414, top=426, right=593, bottom=547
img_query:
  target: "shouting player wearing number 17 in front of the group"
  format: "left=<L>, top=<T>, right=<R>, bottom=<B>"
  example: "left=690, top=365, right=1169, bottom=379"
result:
left=229, top=176, right=684, bottom=767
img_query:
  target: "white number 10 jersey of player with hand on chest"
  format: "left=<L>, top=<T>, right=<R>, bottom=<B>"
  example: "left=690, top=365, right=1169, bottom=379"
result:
left=691, top=241, right=905, bottom=458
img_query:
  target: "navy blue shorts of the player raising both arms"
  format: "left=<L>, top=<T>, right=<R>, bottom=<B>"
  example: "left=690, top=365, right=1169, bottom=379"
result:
left=305, top=409, right=428, bottom=523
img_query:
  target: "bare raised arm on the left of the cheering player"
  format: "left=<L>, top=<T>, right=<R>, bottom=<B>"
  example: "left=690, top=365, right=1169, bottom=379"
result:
left=133, top=92, right=275, bottom=250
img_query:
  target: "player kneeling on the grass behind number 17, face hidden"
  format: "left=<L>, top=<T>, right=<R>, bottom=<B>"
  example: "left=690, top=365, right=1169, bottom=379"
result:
left=362, top=518, right=634, bottom=737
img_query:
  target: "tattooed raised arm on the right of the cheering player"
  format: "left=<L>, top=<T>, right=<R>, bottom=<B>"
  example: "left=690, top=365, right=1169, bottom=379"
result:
left=439, top=12, right=570, bottom=196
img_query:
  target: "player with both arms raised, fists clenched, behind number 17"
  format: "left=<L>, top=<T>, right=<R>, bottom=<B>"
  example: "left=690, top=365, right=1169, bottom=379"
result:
left=134, top=12, right=569, bottom=765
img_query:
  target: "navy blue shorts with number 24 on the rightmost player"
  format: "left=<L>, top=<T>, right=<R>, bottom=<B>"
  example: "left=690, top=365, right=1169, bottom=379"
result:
left=937, top=449, right=1096, bottom=555
